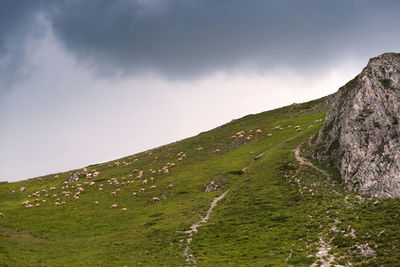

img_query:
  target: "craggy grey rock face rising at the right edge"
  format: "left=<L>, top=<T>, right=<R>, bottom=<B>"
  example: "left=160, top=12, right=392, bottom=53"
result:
left=310, top=53, right=400, bottom=198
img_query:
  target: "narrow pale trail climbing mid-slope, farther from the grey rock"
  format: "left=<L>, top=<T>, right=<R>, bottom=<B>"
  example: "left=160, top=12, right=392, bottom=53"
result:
left=180, top=149, right=270, bottom=266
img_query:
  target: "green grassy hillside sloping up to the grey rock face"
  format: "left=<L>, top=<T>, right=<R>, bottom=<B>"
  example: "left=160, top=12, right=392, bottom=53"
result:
left=0, top=99, right=400, bottom=266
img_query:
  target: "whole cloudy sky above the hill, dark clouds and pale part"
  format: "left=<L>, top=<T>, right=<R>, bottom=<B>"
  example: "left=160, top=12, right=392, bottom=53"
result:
left=0, top=0, right=400, bottom=181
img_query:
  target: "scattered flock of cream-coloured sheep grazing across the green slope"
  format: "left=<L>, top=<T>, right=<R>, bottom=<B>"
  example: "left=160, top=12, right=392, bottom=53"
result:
left=0, top=119, right=322, bottom=220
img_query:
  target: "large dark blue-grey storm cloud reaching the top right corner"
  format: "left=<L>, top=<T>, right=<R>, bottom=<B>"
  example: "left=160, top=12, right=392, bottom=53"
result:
left=3, top=0, right=400, bottom=82
